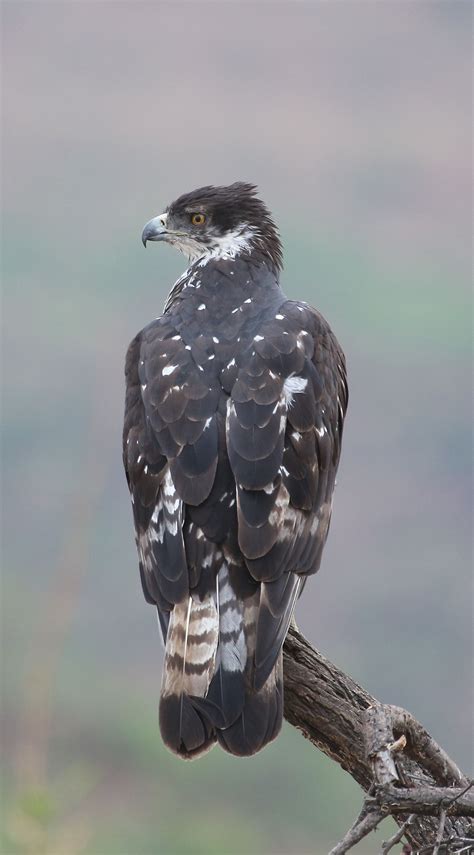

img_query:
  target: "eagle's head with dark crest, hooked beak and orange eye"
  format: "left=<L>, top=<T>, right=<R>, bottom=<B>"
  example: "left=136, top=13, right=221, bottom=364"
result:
left=142, top=181, right=282, bottom=271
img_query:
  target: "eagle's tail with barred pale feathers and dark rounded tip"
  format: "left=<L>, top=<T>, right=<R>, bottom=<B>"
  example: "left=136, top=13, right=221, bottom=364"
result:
left=160, top=564, right=283, bottom=759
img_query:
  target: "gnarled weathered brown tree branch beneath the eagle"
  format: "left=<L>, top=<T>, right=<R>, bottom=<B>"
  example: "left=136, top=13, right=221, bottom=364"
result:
left=284, top=626, right=474, bottom=855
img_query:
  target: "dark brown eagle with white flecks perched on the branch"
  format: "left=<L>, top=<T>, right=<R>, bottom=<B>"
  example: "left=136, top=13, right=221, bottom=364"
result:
left=123, top=181, right=348, bottom=759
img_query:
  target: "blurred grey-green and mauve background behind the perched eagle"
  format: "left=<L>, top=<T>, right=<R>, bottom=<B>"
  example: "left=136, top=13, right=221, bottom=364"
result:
left=1, top=0, right=472, bottom=855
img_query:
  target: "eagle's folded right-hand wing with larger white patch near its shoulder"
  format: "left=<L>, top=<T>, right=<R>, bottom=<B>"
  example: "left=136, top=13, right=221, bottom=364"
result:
left=226, top=301, right=347, bottom=689
